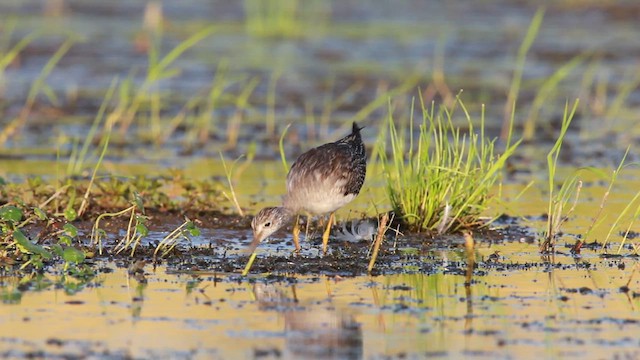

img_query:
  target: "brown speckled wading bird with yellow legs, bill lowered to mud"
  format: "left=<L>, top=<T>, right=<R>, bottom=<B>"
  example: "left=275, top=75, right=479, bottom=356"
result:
left=247, top=121, right=367, bottom=254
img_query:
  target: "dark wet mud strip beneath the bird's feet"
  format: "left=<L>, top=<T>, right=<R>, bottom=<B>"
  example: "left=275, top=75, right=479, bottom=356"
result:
left=8, top=209, right=547, bottom=277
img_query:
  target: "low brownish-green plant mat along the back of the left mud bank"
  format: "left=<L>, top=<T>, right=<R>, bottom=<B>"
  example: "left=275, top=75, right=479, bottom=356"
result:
left=0, top=174, right=225, bottom=218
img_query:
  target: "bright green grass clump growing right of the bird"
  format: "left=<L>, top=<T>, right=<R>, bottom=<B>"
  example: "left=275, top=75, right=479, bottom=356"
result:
left=379, top=97, right=519, bottom=233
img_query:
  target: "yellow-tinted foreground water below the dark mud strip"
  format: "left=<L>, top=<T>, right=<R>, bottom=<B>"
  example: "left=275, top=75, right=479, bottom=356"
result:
left=0, top=249, right=640, bottom=359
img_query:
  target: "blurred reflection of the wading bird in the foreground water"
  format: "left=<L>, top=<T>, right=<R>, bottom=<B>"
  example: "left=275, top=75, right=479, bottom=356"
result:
left=253, top=284, right=363, bottom=359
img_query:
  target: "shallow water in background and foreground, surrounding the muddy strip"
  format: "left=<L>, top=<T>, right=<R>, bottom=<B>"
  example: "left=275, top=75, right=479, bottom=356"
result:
left=0, top=0, right=640, bottom=359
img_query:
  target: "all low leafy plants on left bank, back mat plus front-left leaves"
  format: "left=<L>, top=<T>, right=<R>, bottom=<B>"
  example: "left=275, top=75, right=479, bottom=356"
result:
left=0, top=174, right=224, bottom=270
